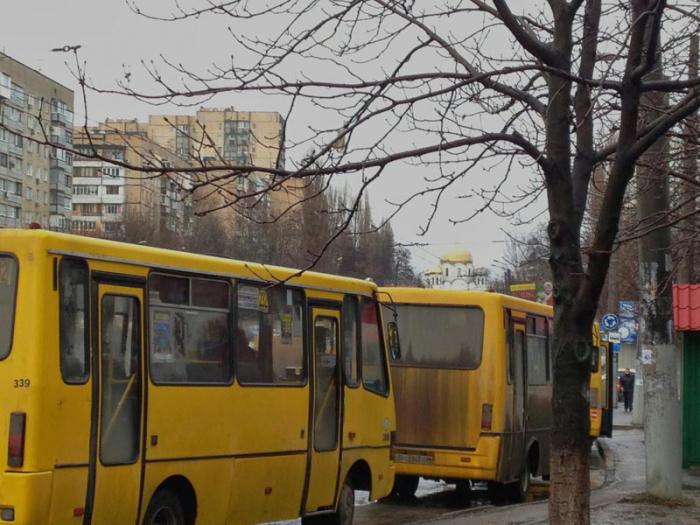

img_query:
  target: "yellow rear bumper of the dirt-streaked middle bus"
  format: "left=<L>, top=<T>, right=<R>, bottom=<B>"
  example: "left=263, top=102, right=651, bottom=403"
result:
left=393, top=436, right=501, bottom=481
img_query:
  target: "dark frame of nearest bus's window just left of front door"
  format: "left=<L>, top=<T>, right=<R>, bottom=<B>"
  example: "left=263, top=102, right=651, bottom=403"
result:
left=231, top=279, right=308, bottom=388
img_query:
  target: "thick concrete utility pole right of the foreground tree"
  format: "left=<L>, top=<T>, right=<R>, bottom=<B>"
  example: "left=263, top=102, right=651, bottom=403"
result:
left=636, top=57, right=682, bottom=498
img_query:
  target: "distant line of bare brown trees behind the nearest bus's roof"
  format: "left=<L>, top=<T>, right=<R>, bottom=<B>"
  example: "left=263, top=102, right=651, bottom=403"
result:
left=116, top=177, right=421, bottom=286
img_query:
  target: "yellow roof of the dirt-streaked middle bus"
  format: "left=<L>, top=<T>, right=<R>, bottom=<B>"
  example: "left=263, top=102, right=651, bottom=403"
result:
left=379, top=287, right=553, bottom=315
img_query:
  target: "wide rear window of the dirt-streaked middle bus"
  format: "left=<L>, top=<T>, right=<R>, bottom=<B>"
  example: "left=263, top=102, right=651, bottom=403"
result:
left=395, top=304, right=484, bottom=369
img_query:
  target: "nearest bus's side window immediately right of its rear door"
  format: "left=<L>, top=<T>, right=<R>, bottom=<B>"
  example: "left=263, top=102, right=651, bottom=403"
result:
left=149, top=274, right=233, bottom=384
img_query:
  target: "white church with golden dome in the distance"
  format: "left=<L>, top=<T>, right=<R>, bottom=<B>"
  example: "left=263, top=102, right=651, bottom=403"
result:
left=423, top=248, right=489, bottom=290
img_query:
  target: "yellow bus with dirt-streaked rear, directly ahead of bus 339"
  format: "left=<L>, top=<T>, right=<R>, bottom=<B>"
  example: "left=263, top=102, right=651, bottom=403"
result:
left=379, top=288, right=553, bottom=501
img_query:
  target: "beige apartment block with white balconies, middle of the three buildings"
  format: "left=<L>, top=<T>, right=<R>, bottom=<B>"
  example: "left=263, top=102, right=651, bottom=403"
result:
left=72, top=120, right=192, bottom=237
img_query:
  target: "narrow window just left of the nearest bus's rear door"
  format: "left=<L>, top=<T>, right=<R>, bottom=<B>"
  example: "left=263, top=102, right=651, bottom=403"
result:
left=59, top=258, right=89, bottom=383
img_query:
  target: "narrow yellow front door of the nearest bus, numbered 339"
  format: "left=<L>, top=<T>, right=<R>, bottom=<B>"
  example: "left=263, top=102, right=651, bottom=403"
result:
left=304, top=308, right=342, bottom=513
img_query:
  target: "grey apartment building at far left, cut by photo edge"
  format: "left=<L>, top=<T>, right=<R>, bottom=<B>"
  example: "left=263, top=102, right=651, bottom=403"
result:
left=0, top=53, right=73, bottom=231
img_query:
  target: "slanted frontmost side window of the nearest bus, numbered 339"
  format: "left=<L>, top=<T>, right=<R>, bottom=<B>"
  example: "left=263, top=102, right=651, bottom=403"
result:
left=361, top=299, right=389, bottom=395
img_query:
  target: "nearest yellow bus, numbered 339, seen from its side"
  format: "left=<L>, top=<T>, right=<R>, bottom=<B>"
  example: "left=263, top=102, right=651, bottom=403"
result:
left=0, top=230, right=395, bottom=525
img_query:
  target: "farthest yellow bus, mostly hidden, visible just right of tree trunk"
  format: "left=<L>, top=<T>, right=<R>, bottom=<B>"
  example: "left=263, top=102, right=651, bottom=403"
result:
left=590, top=323, right=615, bottom=439
